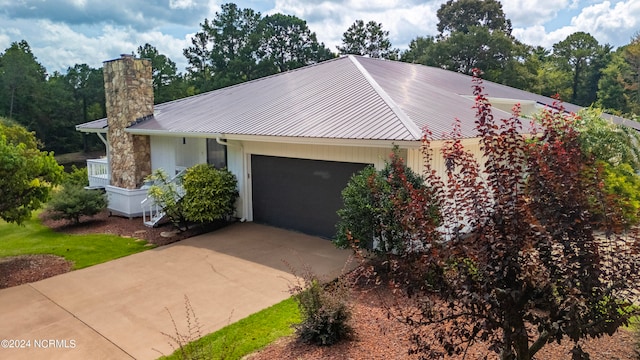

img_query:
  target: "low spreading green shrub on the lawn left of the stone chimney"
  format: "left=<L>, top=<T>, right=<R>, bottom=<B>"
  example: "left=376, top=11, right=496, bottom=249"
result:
left=47, top=184, right=107, bottom=224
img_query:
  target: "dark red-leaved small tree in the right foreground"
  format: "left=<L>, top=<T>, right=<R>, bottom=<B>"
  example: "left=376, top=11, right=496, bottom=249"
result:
left=380, top=74, right=640, bottom=360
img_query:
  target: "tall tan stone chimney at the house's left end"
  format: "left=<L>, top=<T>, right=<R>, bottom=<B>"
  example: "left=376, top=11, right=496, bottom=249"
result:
left=103, top=55, right=153, bottom=189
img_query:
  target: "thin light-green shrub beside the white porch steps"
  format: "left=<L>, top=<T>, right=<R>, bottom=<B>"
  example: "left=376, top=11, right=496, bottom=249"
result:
left=145, top=169, right=188, bottom=229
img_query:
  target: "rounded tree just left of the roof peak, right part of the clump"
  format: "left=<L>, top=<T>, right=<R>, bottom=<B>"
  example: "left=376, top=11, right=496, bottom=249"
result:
left=257, top=13, right=334, bottom=72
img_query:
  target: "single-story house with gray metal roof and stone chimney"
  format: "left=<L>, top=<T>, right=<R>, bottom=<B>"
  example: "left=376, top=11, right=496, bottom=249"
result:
left=76, top=55, right=637, bottom=238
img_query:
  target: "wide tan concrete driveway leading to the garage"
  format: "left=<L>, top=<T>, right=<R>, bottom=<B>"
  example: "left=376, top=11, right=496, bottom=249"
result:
left=0, top=223, right=350, bottom=359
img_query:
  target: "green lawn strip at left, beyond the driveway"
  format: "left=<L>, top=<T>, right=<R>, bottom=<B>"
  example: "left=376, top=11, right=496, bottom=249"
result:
left=0, top=214, right=150, bottom=269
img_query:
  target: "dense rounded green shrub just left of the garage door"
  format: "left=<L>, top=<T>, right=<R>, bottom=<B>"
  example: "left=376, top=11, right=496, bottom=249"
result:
left=182, top=164, right=238, bottom=223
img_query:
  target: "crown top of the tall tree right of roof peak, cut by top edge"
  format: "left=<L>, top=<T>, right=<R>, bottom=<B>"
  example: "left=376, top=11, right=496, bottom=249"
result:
left=436, top=0, right=511, bottom=36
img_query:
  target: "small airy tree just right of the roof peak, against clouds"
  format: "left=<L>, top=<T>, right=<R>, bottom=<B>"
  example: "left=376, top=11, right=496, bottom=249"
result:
left=337, top=20, right=399, bottom=59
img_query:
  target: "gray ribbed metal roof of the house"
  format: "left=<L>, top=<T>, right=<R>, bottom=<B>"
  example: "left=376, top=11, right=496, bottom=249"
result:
left=76, top=56, right=640, bottom=141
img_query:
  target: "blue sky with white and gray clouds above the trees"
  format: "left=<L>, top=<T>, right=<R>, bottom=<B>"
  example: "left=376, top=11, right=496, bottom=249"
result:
left=0, top=0, right=640, bottom=73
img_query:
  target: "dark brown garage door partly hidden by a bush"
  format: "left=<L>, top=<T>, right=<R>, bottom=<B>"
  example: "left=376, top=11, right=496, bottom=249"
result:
left=251, top=155, right=367, bottom=238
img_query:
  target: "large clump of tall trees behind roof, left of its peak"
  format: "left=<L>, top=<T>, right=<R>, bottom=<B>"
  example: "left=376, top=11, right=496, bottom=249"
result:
left=184, top=3, right=333, bottom=91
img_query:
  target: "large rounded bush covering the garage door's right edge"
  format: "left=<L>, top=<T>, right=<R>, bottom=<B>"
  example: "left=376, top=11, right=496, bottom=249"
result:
left=334, top=147, right=439, bottom=254
